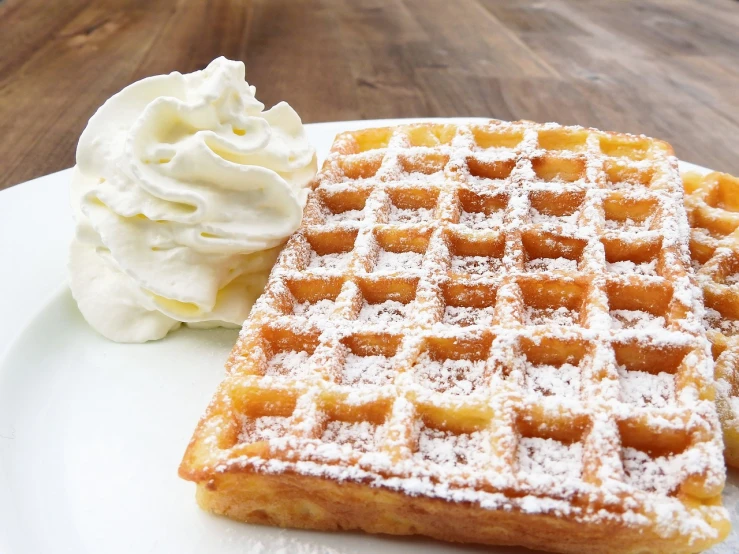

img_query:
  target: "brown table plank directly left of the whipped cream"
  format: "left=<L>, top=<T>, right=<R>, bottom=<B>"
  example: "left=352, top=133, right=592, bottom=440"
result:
left=0, top=0, right=176, bottom=186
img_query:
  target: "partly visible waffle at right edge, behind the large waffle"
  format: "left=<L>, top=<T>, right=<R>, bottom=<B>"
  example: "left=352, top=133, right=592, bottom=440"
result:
left=683, top=169, right=739, bottom=467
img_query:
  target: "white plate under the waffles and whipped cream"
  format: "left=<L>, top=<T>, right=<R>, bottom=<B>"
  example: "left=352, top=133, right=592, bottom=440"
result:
left=0, top=120, right=739, bottom=554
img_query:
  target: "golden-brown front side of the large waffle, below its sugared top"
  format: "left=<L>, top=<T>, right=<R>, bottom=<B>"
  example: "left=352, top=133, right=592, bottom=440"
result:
left=197, top=474, right=720, bottom=554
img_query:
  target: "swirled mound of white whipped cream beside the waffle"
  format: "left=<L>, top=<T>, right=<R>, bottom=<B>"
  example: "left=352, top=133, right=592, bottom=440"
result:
left=69, top=58, right=316, bottom=342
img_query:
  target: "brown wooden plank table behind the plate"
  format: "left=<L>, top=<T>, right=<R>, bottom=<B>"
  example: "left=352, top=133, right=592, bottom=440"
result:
left=0, top=0, right=739, bottom=189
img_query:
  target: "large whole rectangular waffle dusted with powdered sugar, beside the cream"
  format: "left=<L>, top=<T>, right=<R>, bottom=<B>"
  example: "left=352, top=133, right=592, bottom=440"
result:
left=180, top=121, right=729, bottom=553
